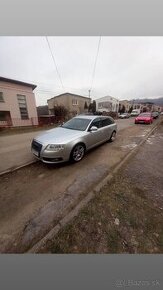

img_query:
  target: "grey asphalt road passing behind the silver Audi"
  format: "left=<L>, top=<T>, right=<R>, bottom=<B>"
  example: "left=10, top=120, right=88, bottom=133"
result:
left=0, top=118, right=134, bottom=173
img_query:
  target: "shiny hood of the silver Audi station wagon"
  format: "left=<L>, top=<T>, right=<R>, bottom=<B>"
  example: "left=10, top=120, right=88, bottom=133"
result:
left=34, top=127, right=86, bottom=145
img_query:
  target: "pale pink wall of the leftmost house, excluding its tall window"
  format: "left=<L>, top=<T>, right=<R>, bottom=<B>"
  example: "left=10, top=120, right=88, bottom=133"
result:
left=0, top=81, right=38, bottom=126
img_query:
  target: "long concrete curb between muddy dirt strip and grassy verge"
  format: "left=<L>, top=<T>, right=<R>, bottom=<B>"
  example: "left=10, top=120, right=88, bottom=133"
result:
left=27, top=119, right=162, bottom=253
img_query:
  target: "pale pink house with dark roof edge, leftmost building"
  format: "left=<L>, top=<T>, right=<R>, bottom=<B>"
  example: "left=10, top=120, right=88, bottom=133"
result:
left=0, top=77, right=38, bottom=127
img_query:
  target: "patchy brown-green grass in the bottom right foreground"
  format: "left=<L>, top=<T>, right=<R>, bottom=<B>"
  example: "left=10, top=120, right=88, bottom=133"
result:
left=47, top=175, right=163, bottom=253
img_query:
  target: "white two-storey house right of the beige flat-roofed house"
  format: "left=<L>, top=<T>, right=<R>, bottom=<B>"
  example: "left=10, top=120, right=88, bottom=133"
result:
left=95, top=96, right=119, bottom=112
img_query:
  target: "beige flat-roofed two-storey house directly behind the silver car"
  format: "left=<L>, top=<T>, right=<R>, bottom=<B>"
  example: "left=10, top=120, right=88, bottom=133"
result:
left=47, top=93, right=91, bottom=116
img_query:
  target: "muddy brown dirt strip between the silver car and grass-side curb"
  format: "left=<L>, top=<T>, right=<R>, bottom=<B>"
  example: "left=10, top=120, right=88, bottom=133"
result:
left=0, top=120, right=158, bottom=252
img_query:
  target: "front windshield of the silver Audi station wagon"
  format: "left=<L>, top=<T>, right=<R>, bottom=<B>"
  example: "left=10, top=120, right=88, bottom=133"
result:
left=62, top=118, right=91, bottom=131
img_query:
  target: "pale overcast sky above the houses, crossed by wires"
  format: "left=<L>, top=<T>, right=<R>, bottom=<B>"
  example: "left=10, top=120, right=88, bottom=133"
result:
left=0, top=37, right=163, bottom=105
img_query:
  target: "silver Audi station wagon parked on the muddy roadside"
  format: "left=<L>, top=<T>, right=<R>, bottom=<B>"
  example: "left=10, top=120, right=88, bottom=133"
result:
left=31, top=115, right=117, bottom=163
